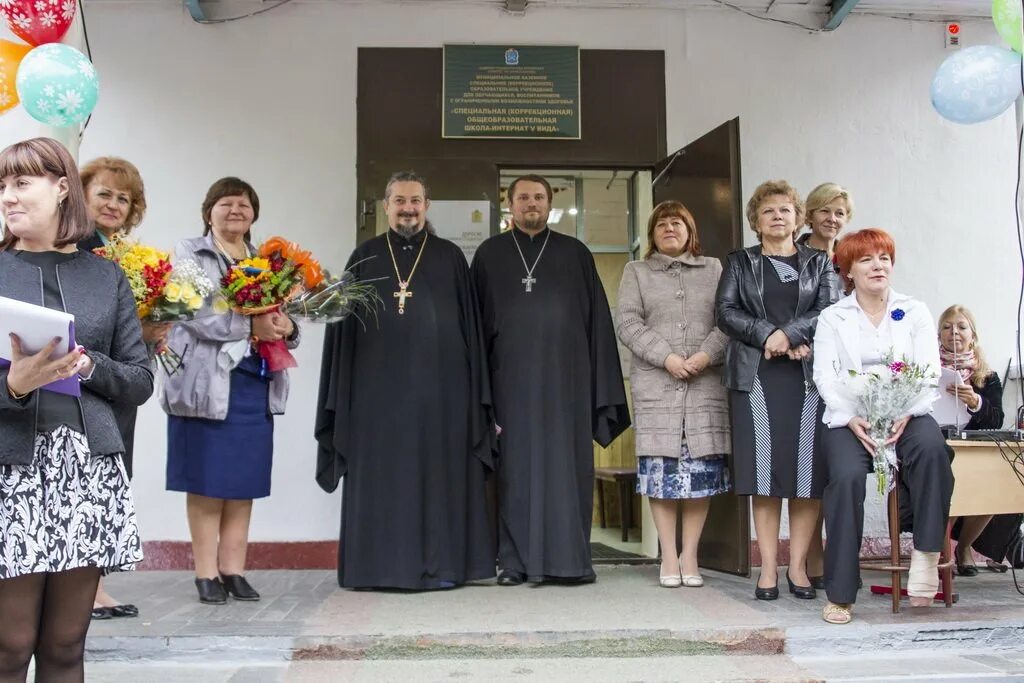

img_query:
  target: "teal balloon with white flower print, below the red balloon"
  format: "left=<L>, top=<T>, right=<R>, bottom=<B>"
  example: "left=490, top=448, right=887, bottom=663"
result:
left=14, top=43, right=99, bottom=128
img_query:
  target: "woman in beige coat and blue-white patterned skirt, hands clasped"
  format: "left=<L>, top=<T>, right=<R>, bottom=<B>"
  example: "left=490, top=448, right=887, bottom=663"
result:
left=615, top=202, right=730, bottom=588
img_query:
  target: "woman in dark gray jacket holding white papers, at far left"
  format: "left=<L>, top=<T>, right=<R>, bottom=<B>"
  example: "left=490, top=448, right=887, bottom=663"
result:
left=0, top=138, right=153, bottom=681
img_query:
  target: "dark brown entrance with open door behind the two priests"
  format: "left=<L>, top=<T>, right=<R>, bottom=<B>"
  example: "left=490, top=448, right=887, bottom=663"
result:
left=354, top=46, right=750, bottom=573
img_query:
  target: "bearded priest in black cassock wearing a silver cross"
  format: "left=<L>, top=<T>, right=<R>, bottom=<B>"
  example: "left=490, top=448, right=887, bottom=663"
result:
left=472, top=176, right=630, bottom=586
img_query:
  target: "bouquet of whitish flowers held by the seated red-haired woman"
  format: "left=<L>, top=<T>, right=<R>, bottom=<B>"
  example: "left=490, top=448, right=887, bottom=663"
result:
left=841, top=353, right=936, bottom=494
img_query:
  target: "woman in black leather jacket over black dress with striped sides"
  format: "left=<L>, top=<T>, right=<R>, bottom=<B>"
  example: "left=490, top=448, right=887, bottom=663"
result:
left=716, top=180, right=838, bottom=600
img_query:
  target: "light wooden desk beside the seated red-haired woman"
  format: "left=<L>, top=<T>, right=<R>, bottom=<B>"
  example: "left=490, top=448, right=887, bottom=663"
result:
left=947, top=441, right=1024, bottom=517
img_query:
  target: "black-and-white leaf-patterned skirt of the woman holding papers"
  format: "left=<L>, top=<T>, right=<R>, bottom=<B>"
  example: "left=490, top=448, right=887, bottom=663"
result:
left=0, top=425, right=142, bottom=580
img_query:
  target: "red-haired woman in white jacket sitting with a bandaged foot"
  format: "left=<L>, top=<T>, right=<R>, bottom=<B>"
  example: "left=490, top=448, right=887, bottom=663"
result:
left=814, top=228, right=953, bottom=624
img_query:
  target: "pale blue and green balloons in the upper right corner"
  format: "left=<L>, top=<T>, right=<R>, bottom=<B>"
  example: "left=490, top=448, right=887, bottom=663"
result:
left=932, top=0, right=1022, bottom=123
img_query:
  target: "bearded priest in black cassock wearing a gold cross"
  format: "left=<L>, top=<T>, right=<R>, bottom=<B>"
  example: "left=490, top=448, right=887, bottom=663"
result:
left=315, top=172, right=495, bottom=590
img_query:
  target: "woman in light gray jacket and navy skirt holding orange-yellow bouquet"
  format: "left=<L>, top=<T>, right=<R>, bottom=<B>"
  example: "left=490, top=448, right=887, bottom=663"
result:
left=161, top=177, right=299, bottom=604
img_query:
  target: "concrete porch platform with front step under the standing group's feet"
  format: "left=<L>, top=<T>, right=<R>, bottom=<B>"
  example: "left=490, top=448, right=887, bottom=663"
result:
left=87, top=566, right=1024, bottom=663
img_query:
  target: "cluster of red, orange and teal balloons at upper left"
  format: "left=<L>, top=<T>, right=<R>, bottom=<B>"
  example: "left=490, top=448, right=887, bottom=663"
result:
left=0, top=0, right=99, bottom=128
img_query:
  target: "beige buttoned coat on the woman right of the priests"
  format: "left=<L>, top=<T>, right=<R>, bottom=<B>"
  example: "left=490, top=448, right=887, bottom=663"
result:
left=615, top=253, right=730, bottom=458
